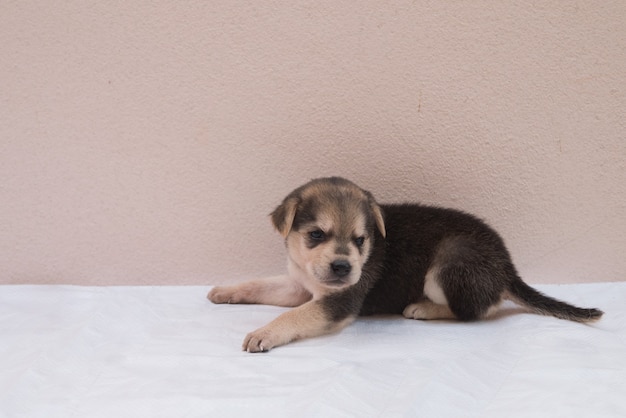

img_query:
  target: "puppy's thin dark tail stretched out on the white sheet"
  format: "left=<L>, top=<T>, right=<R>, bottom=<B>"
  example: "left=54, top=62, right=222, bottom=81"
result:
left=507, top=278, right=604, bottom=322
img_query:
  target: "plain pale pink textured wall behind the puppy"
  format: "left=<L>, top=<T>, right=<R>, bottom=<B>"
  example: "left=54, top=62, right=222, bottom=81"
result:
left=0, top=0, right=626, bottom=284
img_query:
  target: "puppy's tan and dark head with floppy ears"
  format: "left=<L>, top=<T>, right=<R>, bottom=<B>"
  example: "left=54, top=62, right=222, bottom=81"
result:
left=271, top=177, right=385, bottom=288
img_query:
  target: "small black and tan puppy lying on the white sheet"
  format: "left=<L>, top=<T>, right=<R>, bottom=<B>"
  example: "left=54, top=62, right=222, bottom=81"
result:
left=208, top=177, right=603, bottom=353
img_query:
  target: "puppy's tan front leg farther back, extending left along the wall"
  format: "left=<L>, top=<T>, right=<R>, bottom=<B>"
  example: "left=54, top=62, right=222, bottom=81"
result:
left=207, top=275, right=311, bottom=307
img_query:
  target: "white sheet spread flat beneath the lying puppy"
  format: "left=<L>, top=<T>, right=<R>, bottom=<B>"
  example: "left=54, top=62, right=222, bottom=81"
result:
left=0, top=282, right=626, bottom=418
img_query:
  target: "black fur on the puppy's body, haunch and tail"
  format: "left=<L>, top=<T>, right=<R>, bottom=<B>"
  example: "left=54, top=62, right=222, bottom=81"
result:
left=321, top=204, right=602, bottom=322
